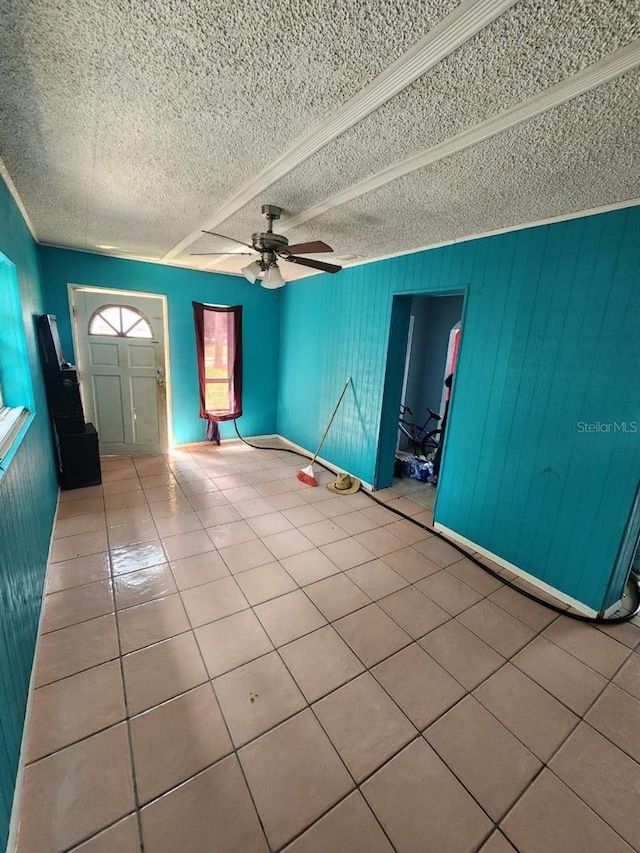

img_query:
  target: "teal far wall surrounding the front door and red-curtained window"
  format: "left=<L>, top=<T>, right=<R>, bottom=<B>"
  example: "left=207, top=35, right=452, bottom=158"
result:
left=40, top=247, right=280, bottom=444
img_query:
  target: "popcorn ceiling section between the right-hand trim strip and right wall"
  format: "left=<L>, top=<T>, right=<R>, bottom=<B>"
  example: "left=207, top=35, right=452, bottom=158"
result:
left=288, top=71, right=640, bottom=256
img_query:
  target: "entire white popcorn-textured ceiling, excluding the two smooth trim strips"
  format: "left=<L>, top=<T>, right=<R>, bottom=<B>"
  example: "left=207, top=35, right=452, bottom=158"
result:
left=0, top=0, right=640, bottom=278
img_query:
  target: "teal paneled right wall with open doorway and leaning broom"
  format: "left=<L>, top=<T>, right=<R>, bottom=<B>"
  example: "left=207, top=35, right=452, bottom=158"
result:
left=278, top=207, right=640, bottom=610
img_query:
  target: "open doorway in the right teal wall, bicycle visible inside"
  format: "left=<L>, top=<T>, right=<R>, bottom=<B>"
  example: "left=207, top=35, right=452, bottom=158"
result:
left=376, top=292, right=464, bottom=511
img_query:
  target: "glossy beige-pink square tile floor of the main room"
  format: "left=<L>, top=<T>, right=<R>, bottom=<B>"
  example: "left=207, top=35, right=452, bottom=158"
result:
left=17, top=444, right=640, bottom=853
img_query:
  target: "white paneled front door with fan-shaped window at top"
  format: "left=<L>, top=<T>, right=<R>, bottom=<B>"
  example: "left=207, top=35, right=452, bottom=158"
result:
left=72, top=288, right=168, bottom=455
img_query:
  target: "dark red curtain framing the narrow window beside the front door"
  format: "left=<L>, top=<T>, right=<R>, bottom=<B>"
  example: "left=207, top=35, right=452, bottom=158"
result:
left=193, top=302, right=242, bottom=444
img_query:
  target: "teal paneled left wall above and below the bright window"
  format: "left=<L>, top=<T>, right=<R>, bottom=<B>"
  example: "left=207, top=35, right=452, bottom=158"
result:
left=0, top=179, right=58, bottom=849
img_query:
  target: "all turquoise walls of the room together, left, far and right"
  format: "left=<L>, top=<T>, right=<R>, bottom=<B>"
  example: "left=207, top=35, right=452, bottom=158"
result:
left=0, top=190, right=640, bottom=842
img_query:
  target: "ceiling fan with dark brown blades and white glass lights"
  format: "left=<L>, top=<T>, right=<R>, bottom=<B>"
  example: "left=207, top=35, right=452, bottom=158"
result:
left=191, top=204, right=342, bottom=290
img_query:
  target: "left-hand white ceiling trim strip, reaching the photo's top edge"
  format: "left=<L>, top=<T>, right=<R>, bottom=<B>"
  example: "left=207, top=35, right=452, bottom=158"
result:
left=163, top=0, right=516, bottom=260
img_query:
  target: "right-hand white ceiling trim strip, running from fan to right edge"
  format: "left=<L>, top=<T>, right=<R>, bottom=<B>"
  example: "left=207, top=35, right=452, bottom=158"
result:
left=278, top=39, right=640, bottom=233
